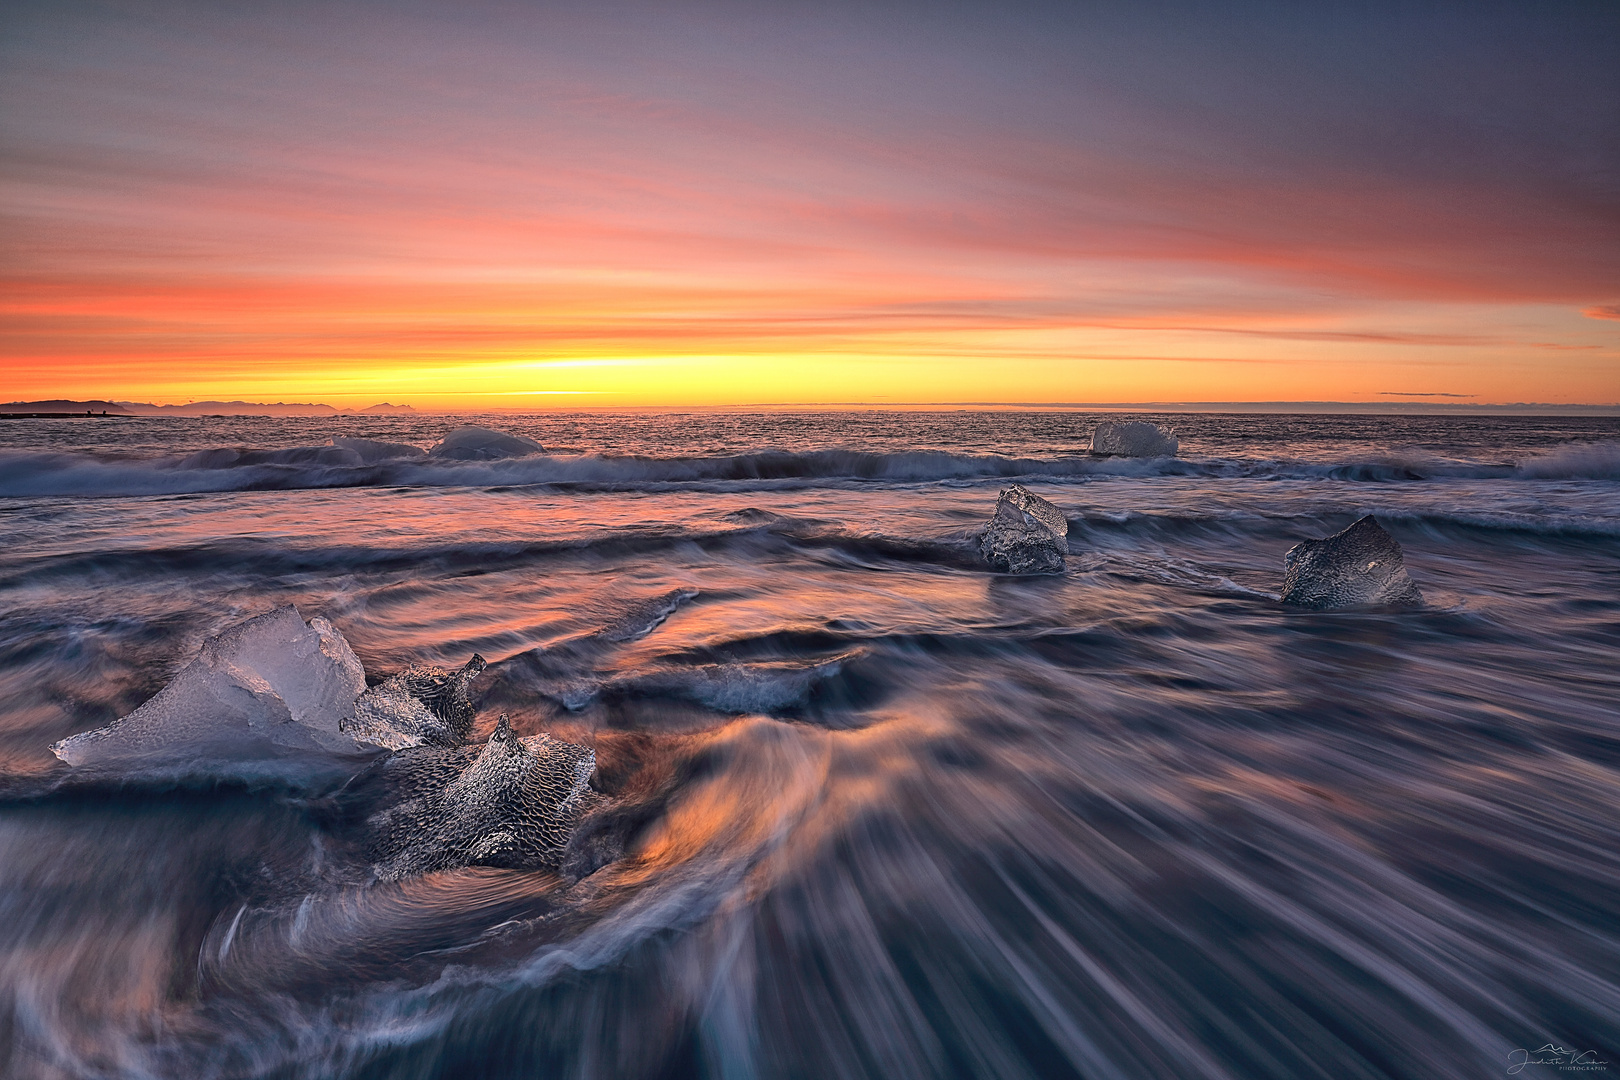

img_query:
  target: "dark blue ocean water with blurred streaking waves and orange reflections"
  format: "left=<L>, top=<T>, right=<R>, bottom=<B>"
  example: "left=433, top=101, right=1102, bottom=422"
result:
left=0, top=411, right=1620, bottom=1080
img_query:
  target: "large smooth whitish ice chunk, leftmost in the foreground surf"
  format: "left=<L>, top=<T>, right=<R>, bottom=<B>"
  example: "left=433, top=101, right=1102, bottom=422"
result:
left=50, top=604, right=366, bottom=766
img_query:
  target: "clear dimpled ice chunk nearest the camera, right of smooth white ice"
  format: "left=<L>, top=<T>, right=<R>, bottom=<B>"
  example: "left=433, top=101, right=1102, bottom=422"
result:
left=368, top=716, right=601, bottom=881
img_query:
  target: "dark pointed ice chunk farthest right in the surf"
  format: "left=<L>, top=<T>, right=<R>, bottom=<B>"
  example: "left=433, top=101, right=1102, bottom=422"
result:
left=1283, top=513, right=1422, bottom=609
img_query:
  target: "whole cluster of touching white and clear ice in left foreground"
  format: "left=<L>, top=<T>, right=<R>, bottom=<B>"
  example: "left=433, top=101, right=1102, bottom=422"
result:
left=52, top=604, right=604, bottom=881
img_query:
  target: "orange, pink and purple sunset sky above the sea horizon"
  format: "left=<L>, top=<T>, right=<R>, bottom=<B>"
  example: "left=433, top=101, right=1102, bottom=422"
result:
left=0, top=0, right=1620, bottom=408
